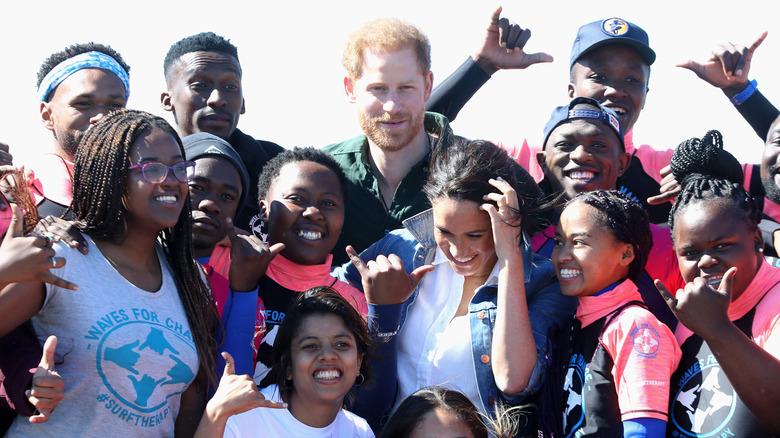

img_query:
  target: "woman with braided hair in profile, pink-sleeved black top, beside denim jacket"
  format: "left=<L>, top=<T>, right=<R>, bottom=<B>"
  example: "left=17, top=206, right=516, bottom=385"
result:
left=540, top=190, right=680, bottom=437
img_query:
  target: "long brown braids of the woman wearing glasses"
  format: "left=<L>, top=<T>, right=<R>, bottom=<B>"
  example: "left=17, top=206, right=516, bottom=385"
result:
left=73, top=110, right=219, bottom=380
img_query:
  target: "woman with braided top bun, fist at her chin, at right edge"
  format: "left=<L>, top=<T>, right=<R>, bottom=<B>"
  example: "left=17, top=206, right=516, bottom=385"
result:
left=656, top=132, right=780, bottom=437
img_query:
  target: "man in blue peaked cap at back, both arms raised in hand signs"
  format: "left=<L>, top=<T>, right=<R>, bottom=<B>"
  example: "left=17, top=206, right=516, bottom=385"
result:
left=427, top=9, right=769, bottom=223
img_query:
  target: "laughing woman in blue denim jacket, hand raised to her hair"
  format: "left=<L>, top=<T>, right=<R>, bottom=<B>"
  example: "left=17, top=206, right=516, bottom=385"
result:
left=337, top=141, right=577, bottom=432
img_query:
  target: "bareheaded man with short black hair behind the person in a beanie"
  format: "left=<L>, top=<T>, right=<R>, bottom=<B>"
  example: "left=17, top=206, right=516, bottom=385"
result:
left=160, top=32, right=284, bottom=230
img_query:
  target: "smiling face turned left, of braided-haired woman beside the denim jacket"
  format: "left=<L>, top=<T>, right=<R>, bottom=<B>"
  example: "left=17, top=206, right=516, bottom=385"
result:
left=551, top=202, right=634, bottom=297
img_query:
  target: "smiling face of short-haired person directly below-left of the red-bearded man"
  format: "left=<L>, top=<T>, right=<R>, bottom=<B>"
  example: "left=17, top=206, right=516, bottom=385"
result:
left=261, top=161, right=344, bottom=265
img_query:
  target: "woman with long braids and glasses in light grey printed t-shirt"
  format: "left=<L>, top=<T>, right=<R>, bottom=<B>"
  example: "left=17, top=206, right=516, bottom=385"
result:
left=0, top=110, right=222, bottom=437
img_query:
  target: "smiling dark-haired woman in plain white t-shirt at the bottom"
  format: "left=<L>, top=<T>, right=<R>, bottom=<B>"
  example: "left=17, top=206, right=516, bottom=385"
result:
left=219, top=287, right=374, bottom=438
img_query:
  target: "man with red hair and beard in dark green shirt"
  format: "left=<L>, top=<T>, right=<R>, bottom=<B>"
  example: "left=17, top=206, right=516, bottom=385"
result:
left=325, top=19, right=464, bottom=263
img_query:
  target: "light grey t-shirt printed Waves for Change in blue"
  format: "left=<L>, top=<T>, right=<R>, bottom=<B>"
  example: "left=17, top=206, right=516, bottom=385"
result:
left=7, top=238, right=198, bottom=438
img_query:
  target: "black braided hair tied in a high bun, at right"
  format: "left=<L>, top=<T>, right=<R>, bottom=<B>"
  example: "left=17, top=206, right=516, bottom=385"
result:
left=669, top=131, right=761, bottom=238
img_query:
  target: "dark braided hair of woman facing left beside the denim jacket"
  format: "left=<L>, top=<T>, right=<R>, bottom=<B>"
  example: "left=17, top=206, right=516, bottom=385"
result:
left=566, top=190, right=653, bottom=281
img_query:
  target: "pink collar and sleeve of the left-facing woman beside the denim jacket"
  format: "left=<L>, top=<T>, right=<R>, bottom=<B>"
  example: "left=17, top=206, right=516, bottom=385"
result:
left=577, top=280, right=682, bottom=421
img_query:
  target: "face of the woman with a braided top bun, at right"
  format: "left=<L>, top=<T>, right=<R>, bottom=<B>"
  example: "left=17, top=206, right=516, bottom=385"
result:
left=673, top=200, right=763, bottom=300
